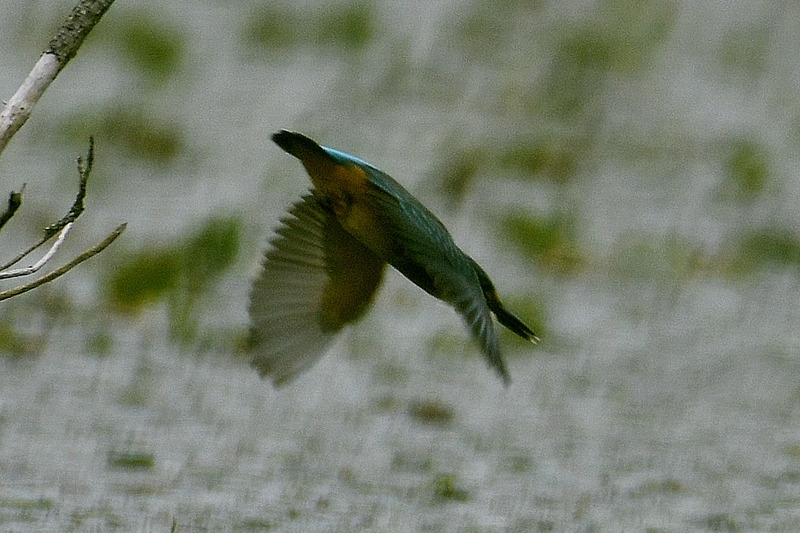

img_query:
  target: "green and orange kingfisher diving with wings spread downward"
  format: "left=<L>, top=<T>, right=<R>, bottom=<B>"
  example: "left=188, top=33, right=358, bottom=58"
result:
left=249, top=130, right=539, bottom=386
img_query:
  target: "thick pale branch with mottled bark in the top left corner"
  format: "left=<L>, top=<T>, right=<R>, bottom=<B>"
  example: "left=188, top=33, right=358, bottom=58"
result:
left=0, top=0, right=114, bottom=154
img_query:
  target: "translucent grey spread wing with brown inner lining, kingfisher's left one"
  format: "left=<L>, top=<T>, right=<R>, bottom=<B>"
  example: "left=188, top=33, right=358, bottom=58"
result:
left=250, top=195, right=384, bottom=385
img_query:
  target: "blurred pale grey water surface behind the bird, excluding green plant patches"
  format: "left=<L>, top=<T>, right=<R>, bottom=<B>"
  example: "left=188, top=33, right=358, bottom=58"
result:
left=0, top=0, right=800, bottom=531
